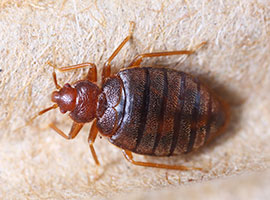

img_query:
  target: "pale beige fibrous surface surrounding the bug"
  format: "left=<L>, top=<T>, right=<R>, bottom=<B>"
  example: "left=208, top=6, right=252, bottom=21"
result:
left=0, top=0, right=270, bottom=199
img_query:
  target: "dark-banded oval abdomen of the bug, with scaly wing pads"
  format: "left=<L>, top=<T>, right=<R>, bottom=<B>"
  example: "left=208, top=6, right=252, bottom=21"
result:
left=97, top=67, right=228, bottom=156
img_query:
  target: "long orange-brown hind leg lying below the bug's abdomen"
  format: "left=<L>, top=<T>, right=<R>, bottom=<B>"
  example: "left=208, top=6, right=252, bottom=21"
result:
left=123, top=150, right=202, bottom=171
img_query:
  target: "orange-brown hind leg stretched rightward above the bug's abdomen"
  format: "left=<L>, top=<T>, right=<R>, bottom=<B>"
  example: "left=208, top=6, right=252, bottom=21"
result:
left=128, top=42, right=206, bottom=67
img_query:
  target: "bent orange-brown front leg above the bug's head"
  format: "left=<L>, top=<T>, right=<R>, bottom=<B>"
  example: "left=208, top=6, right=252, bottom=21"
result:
left=48, top=62, right=97, bottom=82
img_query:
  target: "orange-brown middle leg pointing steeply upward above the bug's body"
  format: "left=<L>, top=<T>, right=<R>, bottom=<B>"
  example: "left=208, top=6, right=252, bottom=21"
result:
left=102, top=22, right=135, bottom=84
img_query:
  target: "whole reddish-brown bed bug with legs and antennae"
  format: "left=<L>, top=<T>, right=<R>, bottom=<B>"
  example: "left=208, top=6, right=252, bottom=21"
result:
left=32, top=23, right=229, bottom=170
